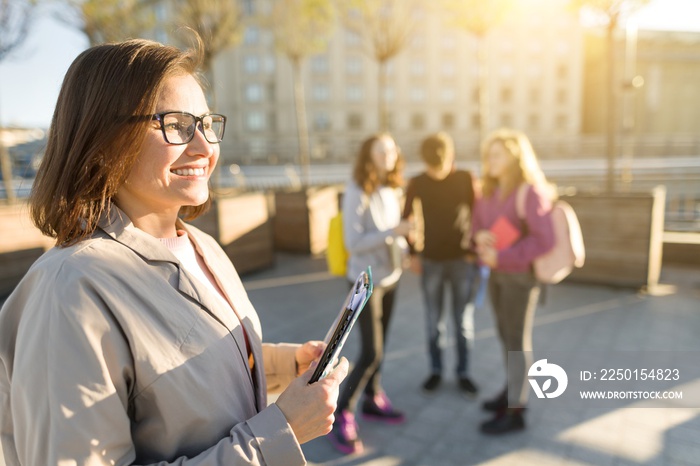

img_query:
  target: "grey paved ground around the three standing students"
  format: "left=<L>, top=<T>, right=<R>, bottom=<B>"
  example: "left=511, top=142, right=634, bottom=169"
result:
left=244, top=254, right=700, bottom=466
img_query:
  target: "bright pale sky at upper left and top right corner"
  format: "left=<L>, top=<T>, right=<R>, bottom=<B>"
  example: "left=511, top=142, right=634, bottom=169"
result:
left=0, top=0, right=700, bottom=128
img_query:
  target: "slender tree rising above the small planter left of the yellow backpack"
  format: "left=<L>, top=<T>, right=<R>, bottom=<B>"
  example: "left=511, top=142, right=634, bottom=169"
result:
left=259, top=0, right=336, bottom=186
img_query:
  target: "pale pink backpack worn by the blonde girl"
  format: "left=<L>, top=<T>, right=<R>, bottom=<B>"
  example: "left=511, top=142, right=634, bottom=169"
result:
left=515, top=184, right=586, bottom=284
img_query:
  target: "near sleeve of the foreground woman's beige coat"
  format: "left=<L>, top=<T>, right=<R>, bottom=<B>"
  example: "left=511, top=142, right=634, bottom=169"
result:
left=3, top=258, right=306, bottom=466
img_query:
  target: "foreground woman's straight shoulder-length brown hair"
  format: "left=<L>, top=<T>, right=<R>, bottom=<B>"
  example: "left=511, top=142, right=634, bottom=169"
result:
left=30, top=37, right=210, bottom=246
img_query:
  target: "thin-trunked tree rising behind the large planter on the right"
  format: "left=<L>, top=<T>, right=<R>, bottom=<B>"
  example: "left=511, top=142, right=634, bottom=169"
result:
left=571, top=0, right=649, bottom=193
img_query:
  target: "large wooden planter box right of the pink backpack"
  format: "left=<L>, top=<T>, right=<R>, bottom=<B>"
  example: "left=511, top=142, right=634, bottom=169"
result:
left=562, top=186, right=666, bottom=289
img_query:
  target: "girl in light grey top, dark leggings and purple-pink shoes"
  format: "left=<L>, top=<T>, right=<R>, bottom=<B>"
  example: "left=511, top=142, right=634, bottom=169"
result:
left=329, top=133, right=409, bottom=454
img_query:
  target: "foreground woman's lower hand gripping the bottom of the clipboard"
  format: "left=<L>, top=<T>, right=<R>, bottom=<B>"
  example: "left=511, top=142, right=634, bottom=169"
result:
left=276, top=356, right=349, bottom=444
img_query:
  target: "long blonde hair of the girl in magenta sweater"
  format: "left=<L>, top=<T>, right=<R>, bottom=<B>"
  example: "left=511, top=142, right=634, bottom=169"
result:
left=481, top=128, right=554, bottom=198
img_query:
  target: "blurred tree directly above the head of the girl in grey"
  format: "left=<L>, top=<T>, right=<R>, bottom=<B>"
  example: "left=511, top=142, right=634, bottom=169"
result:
left=338, top=0, right=430, bottom=130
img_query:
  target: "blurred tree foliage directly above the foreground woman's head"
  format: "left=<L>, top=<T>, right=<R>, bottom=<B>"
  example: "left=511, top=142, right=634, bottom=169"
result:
left=57, top=0, right=159, bottom=45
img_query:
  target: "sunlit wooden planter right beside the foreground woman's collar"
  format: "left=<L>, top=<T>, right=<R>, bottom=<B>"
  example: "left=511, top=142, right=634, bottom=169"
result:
left=190, top=192, right=274, bottom=274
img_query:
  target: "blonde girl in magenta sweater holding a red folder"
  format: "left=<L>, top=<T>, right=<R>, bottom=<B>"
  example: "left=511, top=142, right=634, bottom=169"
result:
left=472, top=129, right=554, bottom=434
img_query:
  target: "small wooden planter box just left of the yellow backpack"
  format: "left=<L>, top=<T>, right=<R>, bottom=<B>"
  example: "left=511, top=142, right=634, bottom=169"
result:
left=274, top=186, right=339, bottom=254
